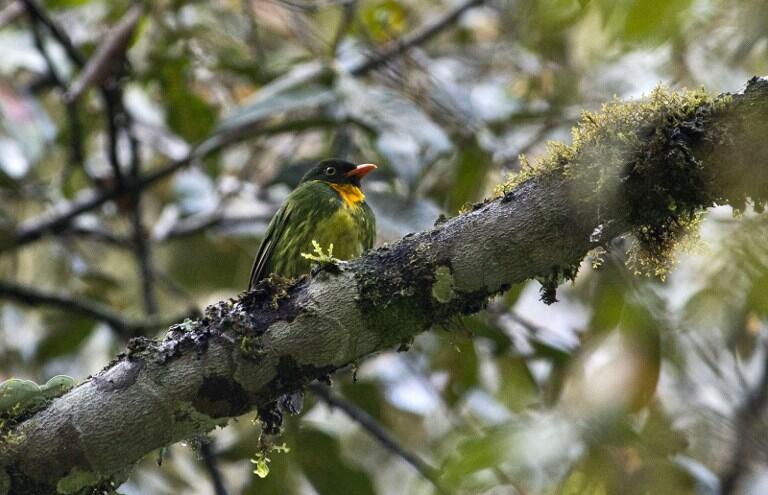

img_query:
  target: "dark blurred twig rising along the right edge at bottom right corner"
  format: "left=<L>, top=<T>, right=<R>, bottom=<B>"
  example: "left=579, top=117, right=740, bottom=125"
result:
left=720, top=343, right=768, bottom=495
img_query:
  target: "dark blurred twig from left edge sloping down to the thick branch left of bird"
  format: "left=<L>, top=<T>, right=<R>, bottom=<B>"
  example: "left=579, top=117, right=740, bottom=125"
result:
left=0, top=280, right=172, bottom=337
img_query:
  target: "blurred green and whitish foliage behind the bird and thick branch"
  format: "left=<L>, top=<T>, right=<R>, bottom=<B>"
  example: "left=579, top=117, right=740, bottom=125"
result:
left=0, top=0, right=768, bottom=495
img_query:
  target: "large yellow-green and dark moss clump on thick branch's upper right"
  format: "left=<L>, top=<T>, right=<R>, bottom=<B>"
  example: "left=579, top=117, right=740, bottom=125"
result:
left=495, top=87, right=732, bottom=280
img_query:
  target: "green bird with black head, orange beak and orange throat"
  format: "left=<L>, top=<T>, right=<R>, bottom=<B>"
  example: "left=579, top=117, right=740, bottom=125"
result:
left=248, top=159, right=376, bottom=290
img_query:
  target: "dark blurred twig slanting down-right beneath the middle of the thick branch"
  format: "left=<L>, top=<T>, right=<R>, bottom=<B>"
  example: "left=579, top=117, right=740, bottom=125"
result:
left=308, top=383, right=450, bottom=493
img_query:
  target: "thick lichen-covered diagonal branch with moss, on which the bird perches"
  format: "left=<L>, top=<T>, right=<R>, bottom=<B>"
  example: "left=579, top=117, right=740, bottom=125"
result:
left=0, top=79, right=768, bottom=495
